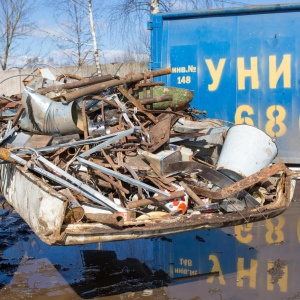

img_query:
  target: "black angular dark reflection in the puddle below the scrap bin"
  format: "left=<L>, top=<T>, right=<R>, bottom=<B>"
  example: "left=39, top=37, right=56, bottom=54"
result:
left=72, top=250, right=168, bottom=298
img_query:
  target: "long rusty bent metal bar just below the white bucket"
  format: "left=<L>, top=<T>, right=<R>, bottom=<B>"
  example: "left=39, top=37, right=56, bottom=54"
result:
left=189, top=162, right=287, bottom=200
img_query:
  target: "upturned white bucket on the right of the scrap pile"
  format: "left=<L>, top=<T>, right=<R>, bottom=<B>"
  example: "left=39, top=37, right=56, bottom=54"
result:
left=216, top=125, right=277, bottom=180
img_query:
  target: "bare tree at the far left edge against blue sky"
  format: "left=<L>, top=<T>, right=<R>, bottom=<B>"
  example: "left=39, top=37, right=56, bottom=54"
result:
left=0, top=0, right=34, bottom=70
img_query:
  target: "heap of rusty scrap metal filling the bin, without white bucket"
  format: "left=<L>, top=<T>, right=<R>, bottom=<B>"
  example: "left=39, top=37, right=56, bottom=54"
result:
left=0, top=69, right=285, bottom=227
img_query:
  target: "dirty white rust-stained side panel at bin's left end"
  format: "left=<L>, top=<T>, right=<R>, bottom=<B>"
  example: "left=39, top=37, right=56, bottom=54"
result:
left=0, top=164, right=67, bottom=244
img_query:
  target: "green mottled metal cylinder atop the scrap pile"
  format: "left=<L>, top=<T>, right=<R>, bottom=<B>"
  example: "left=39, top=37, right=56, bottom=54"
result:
left=138, top=86, right=194, bottom=110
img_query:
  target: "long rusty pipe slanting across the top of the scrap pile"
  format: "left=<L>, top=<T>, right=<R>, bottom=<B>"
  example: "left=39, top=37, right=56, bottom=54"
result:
left=61, top=68, right=172, bottom=103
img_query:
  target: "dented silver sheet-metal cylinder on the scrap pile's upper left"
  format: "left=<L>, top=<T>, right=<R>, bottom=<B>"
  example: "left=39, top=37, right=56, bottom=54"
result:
left=20, top=88, right=83, bottom=134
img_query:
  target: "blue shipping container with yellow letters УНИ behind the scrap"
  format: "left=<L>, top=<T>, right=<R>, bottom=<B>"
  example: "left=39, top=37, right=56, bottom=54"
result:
left=148, top=3, right=300, bottom=164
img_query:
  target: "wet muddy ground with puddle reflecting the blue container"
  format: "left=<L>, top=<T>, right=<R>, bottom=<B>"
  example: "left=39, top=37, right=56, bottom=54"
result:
left=0, top=183, right=300, bottom=300
